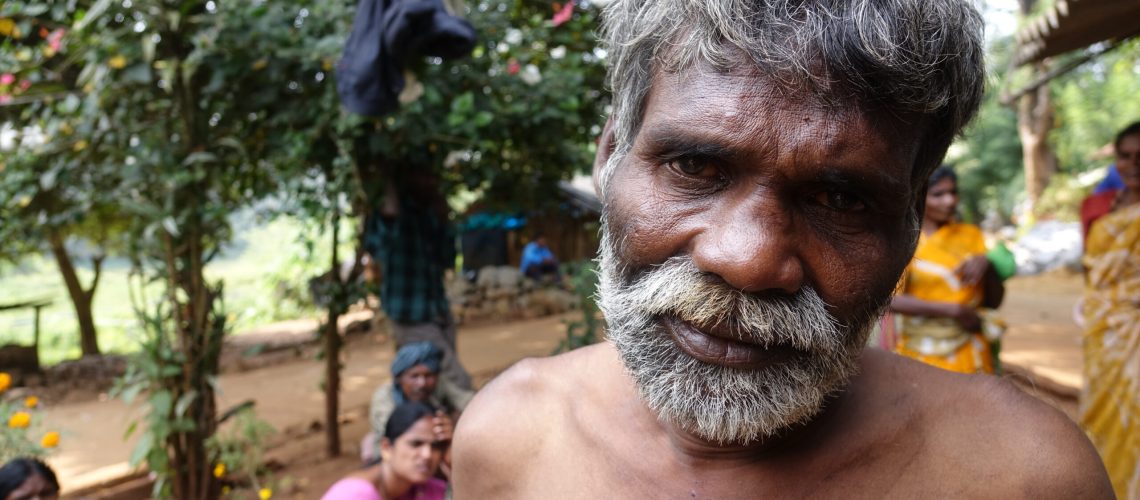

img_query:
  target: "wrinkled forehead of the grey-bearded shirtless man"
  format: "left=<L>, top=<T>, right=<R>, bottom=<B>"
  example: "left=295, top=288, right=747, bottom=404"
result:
left=635, top=66, right=923, bottom=177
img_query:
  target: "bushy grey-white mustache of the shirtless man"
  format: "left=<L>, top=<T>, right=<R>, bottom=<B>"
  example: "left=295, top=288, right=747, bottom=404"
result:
left=608, top=256, right=845, bottom=352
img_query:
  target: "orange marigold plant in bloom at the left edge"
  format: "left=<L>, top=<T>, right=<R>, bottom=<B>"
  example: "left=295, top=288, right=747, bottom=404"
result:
left=0, top=371, right=59, bottom=464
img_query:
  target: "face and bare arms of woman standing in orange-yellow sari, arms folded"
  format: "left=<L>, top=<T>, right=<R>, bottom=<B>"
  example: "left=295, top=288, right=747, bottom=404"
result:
left=890, top=178, right=1005, bottom=331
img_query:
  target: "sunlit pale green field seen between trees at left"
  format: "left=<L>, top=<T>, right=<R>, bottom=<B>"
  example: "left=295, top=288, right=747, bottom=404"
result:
left=0, top=218, right=335, bottom=364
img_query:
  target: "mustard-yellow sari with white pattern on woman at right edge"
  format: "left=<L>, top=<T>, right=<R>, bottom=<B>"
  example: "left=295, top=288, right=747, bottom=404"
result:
left=1080, top=205, right=1140, bottom=499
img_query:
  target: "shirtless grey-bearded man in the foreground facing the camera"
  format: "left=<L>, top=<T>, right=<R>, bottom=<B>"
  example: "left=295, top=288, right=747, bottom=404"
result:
left=453, top=0, right=1112, bottom=499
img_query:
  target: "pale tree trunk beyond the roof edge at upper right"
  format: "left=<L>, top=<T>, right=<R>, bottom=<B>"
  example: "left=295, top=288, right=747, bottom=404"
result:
left=1017, top=63, right=1057, bottom=213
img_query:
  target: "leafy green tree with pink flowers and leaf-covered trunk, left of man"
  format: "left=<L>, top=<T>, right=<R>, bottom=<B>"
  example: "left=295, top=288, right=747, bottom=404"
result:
left=0, top=0, right=608, bottom=499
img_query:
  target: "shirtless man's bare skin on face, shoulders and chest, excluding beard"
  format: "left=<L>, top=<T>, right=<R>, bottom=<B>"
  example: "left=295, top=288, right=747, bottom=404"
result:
left=453, top=71, right=1110, bottom=499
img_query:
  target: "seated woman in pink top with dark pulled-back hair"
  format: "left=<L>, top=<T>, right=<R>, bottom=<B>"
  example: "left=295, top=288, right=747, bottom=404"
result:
left=321, top=401, right=451, bottom=500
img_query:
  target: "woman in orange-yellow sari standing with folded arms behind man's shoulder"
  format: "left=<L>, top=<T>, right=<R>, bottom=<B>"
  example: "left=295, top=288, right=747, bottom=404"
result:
left=890, top=165, right=1005, bottom=374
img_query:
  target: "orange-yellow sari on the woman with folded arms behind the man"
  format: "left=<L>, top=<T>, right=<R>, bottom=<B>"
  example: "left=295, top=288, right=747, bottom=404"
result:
left=896, top=222, right=993, bottom=374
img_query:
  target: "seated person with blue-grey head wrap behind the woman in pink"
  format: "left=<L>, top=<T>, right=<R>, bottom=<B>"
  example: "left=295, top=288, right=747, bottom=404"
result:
left=360, top=341, right=475, bottom=461
